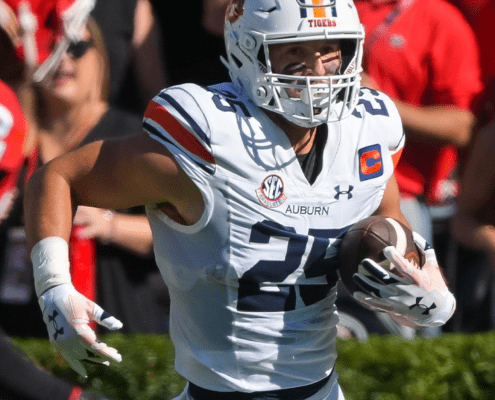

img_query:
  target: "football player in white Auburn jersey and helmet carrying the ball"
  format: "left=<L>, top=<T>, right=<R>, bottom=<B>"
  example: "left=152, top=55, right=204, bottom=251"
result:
left=25, top=0, right=455, bottom=399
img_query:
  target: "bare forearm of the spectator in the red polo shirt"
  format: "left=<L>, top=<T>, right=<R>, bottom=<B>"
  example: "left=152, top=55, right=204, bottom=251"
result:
left=394, top=101, right=475, bottom=147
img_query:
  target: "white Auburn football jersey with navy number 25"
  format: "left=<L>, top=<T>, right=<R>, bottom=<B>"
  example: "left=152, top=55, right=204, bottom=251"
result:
left=144, top=84, right=404, bottom=392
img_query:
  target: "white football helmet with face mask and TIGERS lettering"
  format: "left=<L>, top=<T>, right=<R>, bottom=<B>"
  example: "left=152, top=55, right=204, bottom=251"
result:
left=223, top=0, right=364, bottom=128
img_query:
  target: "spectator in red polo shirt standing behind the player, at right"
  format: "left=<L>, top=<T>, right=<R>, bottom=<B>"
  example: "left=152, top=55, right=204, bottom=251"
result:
left=356, top=0, right=483, bottom=248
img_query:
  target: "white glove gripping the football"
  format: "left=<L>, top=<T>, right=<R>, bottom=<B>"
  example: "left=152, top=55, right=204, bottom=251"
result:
left=353, top=232, right=456, bottom=328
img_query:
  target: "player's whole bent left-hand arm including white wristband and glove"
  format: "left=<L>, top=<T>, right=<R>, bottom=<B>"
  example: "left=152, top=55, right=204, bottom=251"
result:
left=24, top=134, right=203, bottom=375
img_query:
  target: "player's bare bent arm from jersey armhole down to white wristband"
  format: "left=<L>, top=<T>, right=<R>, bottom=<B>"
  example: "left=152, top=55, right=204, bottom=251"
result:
left=25, top=134, right=203, bottom=247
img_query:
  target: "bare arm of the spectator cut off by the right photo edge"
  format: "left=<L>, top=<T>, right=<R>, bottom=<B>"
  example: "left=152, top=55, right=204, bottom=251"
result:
left=452, top=121, right=495, bottom=254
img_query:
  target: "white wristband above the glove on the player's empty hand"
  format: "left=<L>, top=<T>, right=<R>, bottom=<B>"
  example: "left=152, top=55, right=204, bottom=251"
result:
left=31, top=236, right=72, bottom=298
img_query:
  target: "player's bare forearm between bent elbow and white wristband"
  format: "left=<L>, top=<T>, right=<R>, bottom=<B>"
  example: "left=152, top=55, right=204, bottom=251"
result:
left=24, top=164, right=73, bottom=249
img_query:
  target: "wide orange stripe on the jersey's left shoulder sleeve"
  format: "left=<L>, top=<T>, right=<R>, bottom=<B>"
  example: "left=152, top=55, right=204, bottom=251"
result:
left=144, top=101, right=215, bottom=164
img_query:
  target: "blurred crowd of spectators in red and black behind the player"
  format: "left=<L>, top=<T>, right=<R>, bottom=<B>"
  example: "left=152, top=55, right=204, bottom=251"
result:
left=0, top=0, right=495, bottom=339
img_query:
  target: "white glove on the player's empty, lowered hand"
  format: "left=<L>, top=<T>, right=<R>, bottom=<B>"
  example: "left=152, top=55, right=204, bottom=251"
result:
left=38, top=283, right=122, bottom=377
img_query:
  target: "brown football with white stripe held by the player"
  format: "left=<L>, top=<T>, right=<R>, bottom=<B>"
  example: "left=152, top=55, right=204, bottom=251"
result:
left=339, top=215, right=422, bottom=294
